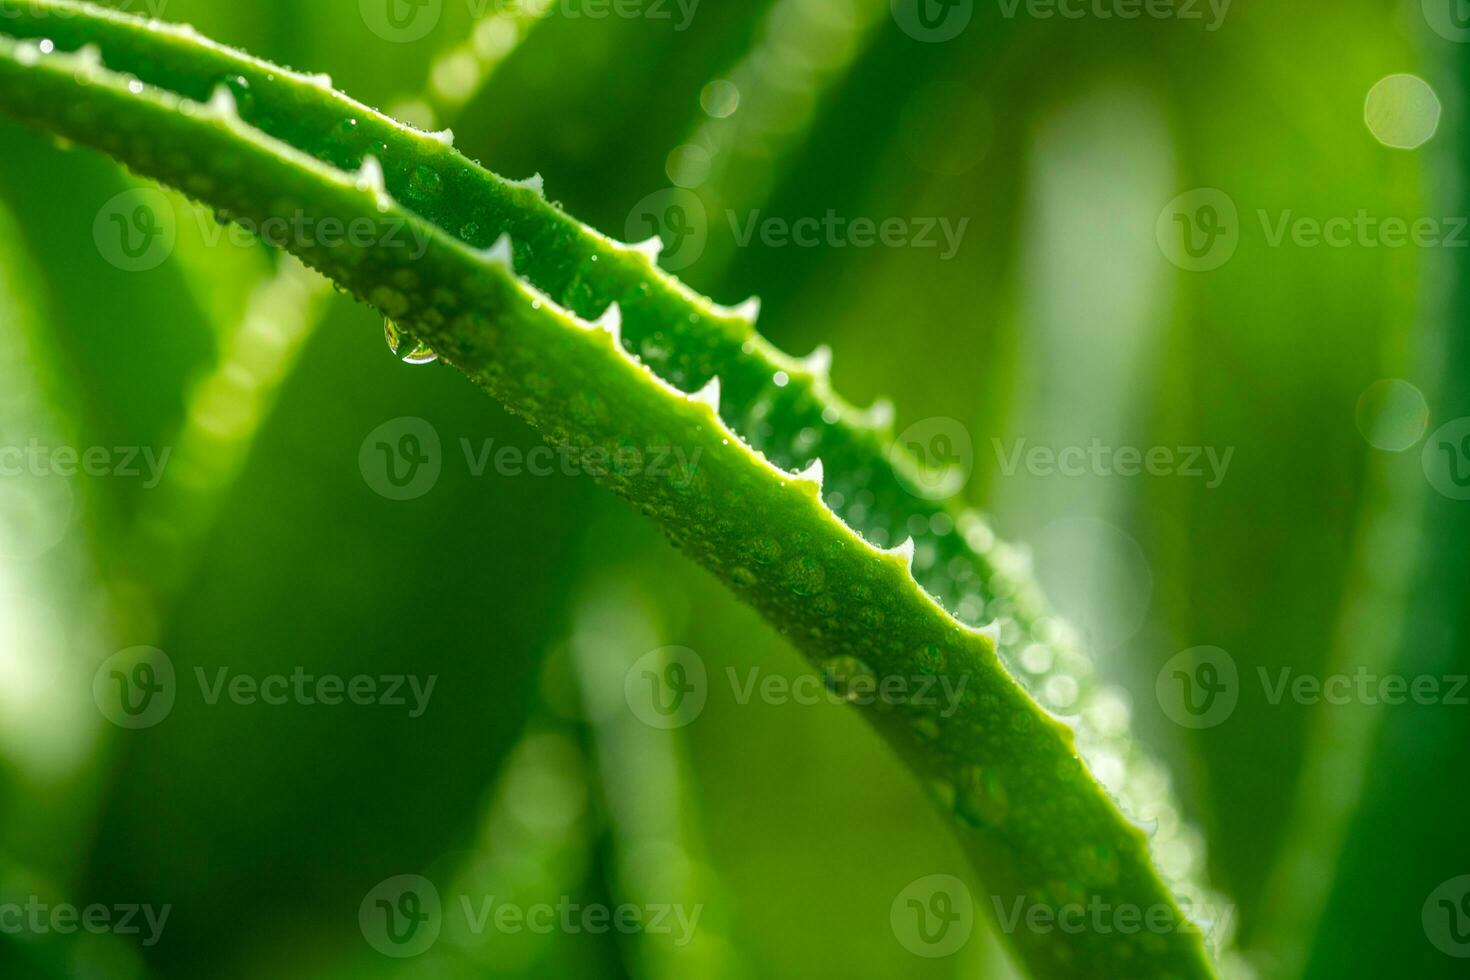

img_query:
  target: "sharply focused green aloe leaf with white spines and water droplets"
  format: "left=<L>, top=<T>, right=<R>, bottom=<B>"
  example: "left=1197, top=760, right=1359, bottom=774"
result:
left=0, top=0, right=1214, bottom=977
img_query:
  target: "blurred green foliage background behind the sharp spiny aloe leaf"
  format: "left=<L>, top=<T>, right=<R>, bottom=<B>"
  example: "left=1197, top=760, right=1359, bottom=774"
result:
left=0, top=0, right=1470, bottom=979
